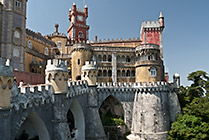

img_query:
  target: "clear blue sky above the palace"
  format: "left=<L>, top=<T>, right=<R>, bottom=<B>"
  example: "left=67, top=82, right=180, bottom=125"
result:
left=26, top=0, right=209, bottom=85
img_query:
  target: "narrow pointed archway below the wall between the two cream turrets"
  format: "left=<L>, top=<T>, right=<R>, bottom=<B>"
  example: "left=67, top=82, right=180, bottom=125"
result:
left=67, top=99, right=85, bottom=140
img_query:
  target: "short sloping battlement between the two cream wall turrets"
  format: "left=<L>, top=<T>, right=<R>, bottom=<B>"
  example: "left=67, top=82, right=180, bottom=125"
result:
left=66, top=80, right=89, bottom=98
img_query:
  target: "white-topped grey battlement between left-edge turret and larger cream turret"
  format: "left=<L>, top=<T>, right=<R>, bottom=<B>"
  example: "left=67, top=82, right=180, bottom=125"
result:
left=11, top=85, right=54, bottom=110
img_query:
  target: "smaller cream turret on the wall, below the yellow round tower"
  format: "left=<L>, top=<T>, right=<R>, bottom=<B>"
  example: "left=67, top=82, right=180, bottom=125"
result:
left=81, top=61, right=98, bottom=86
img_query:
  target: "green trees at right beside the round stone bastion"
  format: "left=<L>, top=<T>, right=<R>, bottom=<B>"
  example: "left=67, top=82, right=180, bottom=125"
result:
left=168, top=71, right=209, bottom=140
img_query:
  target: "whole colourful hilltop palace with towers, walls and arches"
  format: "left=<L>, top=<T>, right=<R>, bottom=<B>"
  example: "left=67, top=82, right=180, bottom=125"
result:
left=0, top=0, right=180, bottom=140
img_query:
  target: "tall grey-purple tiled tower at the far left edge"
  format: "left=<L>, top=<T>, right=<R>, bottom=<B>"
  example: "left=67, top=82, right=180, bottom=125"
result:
left=0, top=0, right=27, bottom=71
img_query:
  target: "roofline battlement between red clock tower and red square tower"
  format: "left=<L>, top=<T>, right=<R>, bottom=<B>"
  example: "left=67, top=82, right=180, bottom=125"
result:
left=90, top=37, right=141, bottom=43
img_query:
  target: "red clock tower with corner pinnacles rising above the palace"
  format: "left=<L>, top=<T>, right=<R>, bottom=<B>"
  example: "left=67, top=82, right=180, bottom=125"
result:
left=67, top=3, right=89, bottom=44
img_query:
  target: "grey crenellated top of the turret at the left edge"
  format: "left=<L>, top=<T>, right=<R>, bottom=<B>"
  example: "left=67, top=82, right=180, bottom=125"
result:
left=0, top=58, right=14, bottom=77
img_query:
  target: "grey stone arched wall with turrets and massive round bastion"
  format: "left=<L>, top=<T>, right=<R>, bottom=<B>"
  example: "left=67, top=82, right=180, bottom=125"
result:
left=0, top=59, right=180, bottom=140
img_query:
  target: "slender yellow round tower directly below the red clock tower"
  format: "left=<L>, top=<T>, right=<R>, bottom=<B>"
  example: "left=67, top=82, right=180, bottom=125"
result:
left=71, top=43, right=92, bottom=81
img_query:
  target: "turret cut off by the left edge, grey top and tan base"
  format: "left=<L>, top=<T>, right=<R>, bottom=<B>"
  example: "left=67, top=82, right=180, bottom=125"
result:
left=0, top=58, right=14, bottom=108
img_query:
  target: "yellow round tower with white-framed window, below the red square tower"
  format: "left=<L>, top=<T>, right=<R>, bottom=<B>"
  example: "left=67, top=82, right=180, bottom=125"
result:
left=136, top=44, right=165, bottom=82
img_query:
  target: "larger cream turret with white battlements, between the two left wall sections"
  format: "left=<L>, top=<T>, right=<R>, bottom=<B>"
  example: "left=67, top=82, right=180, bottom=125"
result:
left=45, top=59, right=68, bottom=94
